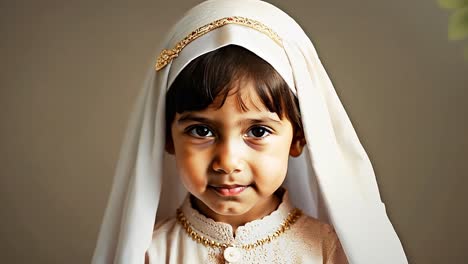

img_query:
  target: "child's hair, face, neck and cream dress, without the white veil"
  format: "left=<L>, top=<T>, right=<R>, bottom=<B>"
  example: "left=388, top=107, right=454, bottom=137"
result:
left=148, top=45, right=347, bottom=264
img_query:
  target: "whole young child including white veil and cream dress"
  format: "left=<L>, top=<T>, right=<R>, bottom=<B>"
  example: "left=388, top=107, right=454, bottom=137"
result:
left=93, top=0, right=407, bottom=264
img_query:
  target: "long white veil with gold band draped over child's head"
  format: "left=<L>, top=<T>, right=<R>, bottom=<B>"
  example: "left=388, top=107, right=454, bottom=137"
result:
left=92, top=0, right=407, bottom=264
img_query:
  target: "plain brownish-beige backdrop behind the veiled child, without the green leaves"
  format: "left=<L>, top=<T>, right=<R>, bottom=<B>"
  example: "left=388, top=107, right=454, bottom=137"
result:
left=0, top=0, right=468, bottom=264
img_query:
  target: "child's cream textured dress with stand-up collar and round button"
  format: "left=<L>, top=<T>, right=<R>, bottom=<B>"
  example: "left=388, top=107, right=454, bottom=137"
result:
left=147, top=192, right=348, bottom=264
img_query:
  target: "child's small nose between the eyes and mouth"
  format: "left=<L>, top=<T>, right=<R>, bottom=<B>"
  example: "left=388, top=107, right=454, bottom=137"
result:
left=212, top=139, right=242, bottom=174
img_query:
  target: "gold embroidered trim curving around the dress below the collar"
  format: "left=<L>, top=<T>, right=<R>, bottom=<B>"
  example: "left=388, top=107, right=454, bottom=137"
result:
left=177, top=208, right=302, bottom=250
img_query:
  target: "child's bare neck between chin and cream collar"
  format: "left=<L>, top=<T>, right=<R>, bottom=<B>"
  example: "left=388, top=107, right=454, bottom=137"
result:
left=190, top=194, right=281, bottom=232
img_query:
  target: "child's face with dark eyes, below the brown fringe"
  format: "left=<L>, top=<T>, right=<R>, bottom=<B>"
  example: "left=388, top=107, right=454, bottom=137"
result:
left=170, top=82, right=300, bottom=220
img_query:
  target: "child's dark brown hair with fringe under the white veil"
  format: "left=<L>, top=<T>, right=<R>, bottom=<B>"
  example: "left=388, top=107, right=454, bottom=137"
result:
left=166, top=45, right=302, bottom=139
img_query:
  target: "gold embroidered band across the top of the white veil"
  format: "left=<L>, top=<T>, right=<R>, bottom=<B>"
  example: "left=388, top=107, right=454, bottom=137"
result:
left=155, top=16, right=283, bottom=71
